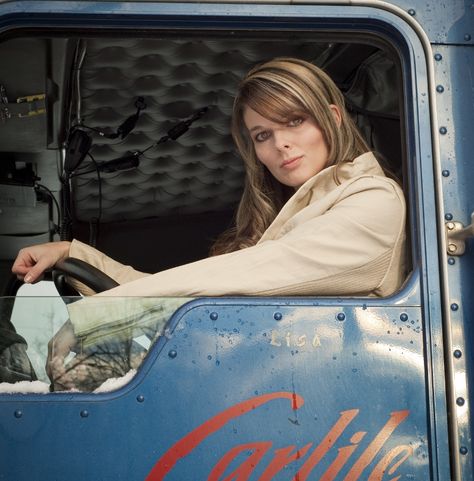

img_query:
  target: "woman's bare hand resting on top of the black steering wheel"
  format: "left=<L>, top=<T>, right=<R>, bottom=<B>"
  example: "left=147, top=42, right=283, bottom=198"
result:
left=12, top=241, right=71, bottom=284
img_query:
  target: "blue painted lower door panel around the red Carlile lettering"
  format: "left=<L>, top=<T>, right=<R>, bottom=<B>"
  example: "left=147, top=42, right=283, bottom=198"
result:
left=0, top=299, right=430, bottom=480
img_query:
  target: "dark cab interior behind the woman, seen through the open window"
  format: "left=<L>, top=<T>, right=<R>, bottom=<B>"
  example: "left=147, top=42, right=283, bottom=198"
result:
left=0, top=29, right=406, bottom=390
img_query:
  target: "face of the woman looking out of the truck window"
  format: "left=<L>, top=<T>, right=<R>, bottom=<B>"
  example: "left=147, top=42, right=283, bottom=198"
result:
left=243, top=107, right=328, bottom=188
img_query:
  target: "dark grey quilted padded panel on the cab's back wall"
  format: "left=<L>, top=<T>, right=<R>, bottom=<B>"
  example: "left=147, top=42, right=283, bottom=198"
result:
left=73, top=38, right=336, bottom=222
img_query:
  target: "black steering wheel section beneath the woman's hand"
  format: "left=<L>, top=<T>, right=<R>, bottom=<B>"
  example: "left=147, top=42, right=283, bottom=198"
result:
left=52, top=257, right=119, bottom=297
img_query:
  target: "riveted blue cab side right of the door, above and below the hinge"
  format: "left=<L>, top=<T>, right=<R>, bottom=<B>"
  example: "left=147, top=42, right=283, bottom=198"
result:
left=434, top=42, right=474, bottom=479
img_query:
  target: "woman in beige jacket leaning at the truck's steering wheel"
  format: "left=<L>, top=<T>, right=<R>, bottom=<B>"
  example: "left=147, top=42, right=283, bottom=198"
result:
left=12, top=58, right=405, bottom=390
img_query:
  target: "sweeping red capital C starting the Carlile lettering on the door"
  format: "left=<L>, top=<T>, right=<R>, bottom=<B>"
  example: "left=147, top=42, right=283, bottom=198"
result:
left=146, top=392, right=304, bottom=481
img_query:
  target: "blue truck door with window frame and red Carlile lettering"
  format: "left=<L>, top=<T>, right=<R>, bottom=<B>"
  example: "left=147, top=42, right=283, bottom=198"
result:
left=0, top=2, right=473, bottom=481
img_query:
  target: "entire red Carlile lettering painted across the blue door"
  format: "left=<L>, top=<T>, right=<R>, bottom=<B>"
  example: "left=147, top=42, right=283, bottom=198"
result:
left=146, top=392, right=413, bottom=481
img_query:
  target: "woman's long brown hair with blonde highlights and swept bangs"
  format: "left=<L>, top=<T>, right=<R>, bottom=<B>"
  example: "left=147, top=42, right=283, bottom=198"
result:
left=211, top=58, right=370, bottom=255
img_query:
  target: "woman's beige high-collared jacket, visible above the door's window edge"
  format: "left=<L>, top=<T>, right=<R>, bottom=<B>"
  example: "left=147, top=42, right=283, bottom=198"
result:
left=70, top=153, right=405, bottom=298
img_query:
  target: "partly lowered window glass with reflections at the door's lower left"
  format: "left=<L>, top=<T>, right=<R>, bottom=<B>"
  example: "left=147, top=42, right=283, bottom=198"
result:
left=0, top=290, right=186, bottom=393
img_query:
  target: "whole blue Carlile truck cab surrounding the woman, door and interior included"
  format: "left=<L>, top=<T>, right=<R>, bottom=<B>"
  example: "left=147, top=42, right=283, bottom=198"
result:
left=0, top=0, right=474, bottom=481
